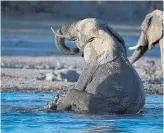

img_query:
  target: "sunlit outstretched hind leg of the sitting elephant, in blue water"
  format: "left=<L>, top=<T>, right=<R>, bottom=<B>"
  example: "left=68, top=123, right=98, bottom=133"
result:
left=43, top=89, right=92, bottom=113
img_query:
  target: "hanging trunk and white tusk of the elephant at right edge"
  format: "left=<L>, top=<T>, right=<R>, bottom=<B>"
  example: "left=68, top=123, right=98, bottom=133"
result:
left=129, top=32, right=148, bottom=64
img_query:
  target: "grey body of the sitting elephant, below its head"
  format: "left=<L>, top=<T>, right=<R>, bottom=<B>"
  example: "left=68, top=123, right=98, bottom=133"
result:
left=52, top=57, right=145, bottom=114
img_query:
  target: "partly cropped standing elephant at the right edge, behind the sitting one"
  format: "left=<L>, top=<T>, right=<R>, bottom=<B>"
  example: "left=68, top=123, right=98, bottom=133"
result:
left=129, top=10, right=164, bottom=71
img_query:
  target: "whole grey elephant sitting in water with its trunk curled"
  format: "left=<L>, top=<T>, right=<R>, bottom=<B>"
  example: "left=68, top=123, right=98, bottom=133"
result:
left=48, top=18, right=145, bottom=114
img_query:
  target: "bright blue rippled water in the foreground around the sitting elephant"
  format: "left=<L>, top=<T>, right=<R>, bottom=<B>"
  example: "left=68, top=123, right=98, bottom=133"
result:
left=1, top=92, right=163, bottom=133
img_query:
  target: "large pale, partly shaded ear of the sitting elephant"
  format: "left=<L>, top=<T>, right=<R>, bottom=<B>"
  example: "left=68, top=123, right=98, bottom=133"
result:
left=84, top=24, right=126, bottom=65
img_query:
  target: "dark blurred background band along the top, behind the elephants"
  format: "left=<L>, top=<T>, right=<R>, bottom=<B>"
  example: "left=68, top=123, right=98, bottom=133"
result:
left=1, top=1, right=163, bottom=23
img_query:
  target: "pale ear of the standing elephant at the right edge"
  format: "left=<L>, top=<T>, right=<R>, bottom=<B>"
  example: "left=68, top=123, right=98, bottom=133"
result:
left=141, top=10, right=163, bottom=48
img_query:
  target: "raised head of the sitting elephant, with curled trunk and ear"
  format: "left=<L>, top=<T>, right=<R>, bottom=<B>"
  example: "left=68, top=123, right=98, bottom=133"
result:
left=52, top=18, right=126, bottom=64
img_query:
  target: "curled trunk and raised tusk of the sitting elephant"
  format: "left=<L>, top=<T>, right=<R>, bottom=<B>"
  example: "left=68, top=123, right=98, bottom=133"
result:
left=51, top=26, right=79, bottom=55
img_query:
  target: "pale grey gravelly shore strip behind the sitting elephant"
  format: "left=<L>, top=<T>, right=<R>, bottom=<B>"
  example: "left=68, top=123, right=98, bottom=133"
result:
left=1, top=56, right=163, bottom=95
